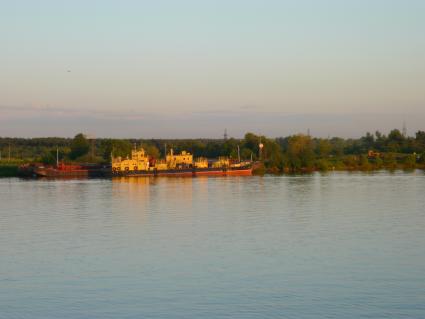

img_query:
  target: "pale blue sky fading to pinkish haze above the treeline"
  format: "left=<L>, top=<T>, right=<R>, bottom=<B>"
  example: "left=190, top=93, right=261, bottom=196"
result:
left=0, top=0, right=425, bottom=138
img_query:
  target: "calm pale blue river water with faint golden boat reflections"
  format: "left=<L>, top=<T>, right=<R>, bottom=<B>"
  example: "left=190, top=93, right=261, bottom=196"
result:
left=0, top=171, right=425, bottom=319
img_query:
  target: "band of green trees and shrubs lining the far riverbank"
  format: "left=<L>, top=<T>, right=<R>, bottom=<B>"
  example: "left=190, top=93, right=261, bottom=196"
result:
left=0, top=129, right=425, bottom=176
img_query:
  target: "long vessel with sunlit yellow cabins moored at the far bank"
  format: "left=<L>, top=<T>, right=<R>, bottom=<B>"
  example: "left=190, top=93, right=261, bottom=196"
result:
left=112, top=148, right=252, bottom=176
